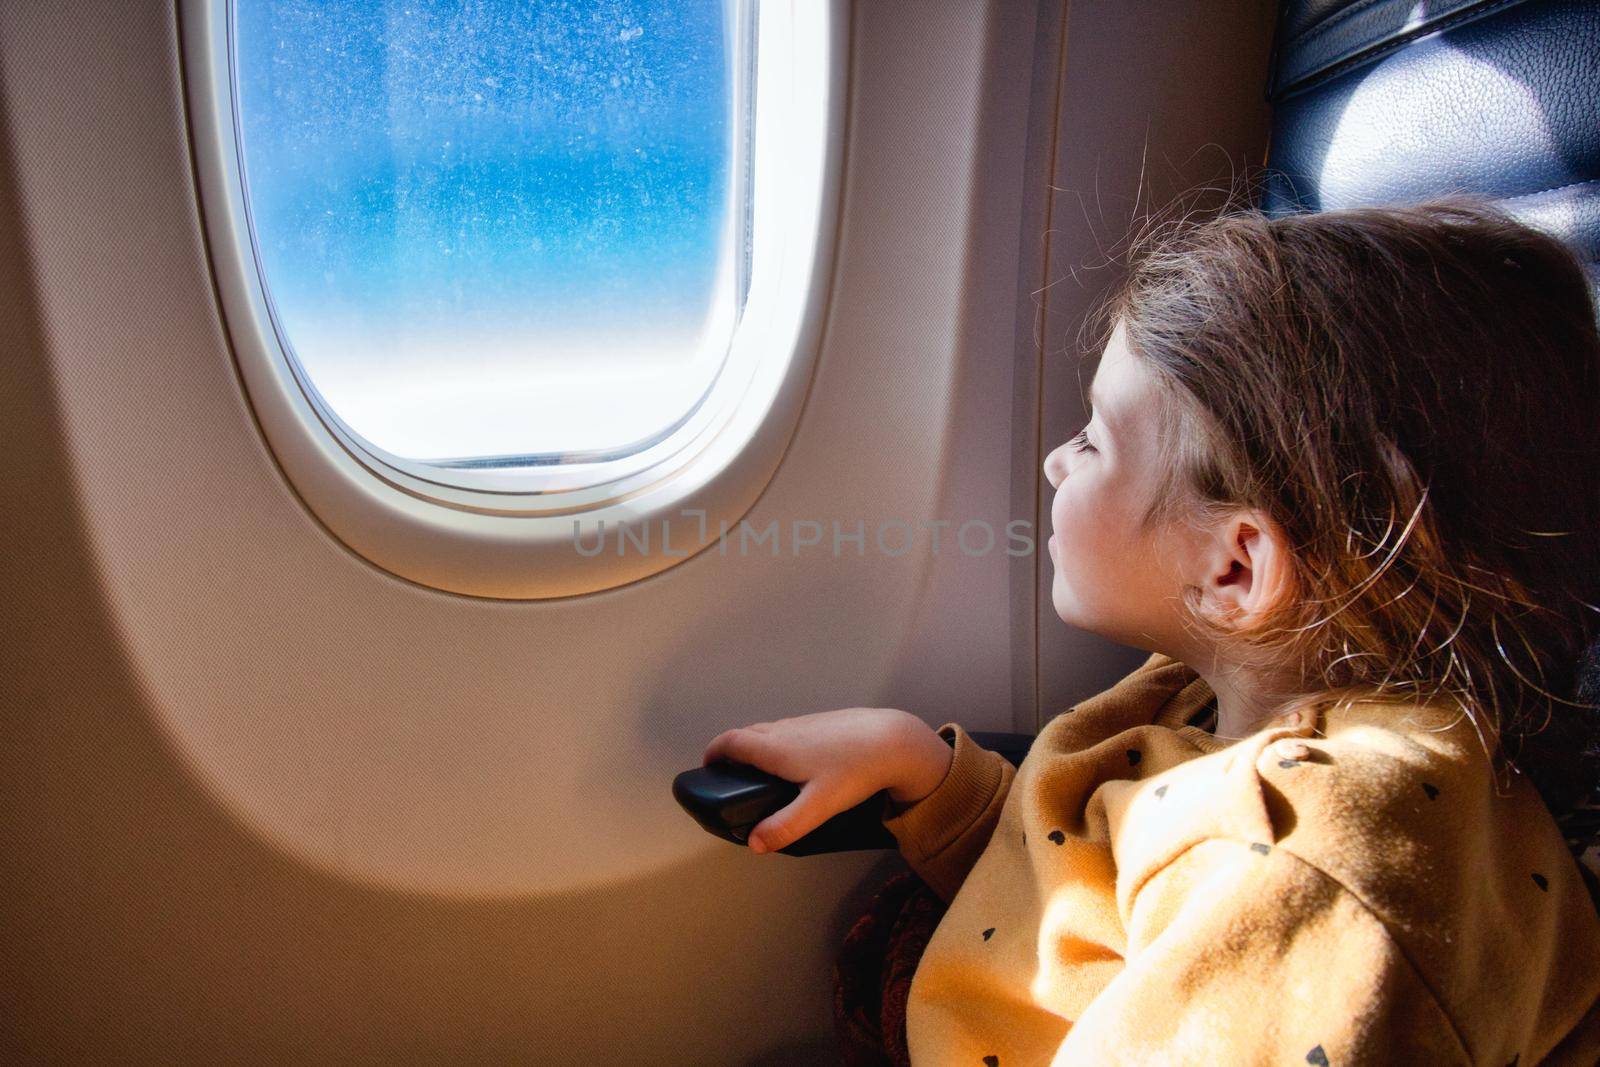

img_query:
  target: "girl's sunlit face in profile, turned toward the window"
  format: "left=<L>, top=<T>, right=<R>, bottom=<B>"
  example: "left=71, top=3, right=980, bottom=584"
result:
left=1045, top=322, right=1202, bottom=653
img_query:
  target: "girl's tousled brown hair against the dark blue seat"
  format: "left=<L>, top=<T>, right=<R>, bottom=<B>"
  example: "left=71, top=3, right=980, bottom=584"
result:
left=1094, top=187, right=1600, bottom=851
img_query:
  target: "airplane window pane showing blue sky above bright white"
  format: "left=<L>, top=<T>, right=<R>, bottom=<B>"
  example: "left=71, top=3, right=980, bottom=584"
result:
left=229, top=0, right=748, bottom=491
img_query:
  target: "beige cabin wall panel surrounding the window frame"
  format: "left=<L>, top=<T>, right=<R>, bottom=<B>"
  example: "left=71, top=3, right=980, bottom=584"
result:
left=0, top=0, right=1270, bottom=1064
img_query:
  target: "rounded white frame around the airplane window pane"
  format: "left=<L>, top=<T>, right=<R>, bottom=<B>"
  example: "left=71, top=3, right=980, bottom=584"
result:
left=179, top=0, right=848, bottom=600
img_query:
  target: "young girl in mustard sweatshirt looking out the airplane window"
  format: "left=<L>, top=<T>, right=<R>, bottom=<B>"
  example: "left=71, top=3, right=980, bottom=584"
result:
left=706, top=198, right=1600, bottom=1067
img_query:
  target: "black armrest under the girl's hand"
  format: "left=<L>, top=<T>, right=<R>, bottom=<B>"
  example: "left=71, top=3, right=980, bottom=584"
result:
left=672, top=733, right=1034, bottom=856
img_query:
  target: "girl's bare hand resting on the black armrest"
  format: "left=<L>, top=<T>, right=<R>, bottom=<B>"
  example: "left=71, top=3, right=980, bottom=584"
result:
left=701, top=707, right=955, bottom=853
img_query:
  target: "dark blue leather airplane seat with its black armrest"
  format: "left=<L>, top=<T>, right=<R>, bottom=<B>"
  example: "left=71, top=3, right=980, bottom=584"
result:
left=674, top=0, right=1600, bottom=893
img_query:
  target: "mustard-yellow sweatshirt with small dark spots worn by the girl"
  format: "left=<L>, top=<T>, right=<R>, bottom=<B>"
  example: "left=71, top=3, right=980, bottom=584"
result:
left=885, top=654, right=1600, bottom=1067
